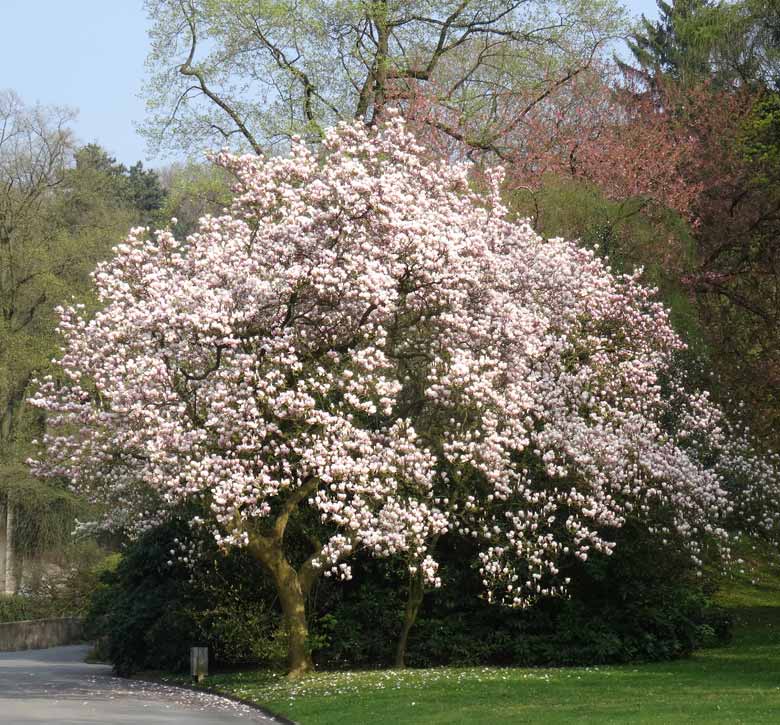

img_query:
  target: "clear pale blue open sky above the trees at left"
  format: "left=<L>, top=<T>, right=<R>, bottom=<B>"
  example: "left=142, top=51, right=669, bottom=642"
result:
left=0, top=0, right=656, bottom=166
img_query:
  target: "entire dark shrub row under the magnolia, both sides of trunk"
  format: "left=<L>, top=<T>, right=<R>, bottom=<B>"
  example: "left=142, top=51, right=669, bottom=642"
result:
left=89, top=510, right=730, bottom=674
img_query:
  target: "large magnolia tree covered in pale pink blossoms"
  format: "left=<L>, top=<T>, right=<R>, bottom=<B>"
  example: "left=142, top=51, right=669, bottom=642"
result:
left=35, top=118, right=774, bottom=674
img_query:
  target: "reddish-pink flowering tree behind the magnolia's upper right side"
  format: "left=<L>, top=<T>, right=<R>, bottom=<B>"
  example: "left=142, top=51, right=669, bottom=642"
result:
left=400, top=62, right=709, bottom=216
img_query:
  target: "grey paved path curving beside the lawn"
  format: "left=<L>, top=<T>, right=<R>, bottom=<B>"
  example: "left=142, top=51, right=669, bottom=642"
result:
left=0, top=645, right=276, bottom=725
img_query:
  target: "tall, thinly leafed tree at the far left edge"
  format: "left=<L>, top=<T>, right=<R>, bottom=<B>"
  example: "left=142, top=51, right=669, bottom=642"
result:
left=0, top=91, right=84, bottom=592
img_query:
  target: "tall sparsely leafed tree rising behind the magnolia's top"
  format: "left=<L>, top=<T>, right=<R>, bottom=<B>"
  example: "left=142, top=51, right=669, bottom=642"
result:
left=140, top=0, right=627, bottom=153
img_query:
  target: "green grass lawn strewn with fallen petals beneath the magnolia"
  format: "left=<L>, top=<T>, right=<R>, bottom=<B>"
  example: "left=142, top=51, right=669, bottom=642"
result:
left=180, top=552, right=780, bottom=725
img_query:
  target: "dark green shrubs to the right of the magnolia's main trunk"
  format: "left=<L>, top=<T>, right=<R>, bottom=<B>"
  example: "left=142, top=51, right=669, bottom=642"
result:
left=317, top=526, right=730, bottom=667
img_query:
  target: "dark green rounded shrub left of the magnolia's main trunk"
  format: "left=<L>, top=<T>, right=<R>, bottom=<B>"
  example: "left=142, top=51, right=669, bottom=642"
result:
left=87, top=521, right=284, bottom=676
